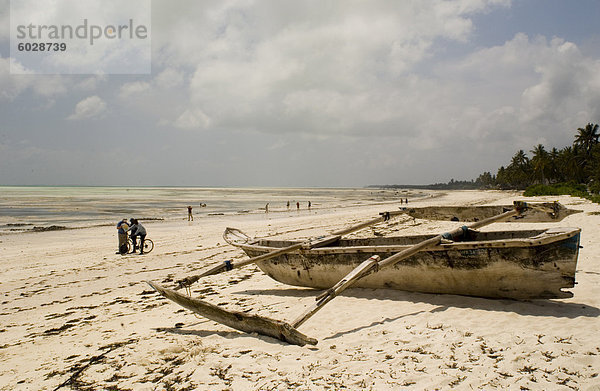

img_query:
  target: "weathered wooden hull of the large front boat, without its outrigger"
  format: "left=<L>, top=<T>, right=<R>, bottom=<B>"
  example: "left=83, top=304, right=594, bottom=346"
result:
left=239, top=228, right=581, bottom=300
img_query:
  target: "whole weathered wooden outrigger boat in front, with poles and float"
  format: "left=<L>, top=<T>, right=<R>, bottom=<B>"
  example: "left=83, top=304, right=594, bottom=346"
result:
left=147, top=201, right=580, bottom=346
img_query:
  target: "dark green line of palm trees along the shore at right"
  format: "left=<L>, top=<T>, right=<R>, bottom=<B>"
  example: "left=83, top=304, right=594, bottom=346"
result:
left=475, top=123, right=600, bottom=193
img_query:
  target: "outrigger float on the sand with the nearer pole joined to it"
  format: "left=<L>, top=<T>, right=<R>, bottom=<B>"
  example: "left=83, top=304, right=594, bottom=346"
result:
left=147, top=203, right=527, bottom=346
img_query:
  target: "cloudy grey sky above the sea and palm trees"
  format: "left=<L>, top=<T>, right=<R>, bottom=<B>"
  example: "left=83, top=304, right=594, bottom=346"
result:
left=0, top=0, right=600, bottom=187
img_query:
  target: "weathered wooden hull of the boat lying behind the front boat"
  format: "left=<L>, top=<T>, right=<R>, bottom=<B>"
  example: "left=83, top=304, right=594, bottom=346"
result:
left=401, top=202, right=582, bottom=223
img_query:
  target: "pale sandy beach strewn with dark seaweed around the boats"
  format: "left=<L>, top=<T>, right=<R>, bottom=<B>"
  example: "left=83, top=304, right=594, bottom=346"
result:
left=0, top=191, right=600, bottom=390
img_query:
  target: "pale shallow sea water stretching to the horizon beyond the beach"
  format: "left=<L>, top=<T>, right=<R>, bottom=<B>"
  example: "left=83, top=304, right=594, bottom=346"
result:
left=0, top=186, right=424, bottom=233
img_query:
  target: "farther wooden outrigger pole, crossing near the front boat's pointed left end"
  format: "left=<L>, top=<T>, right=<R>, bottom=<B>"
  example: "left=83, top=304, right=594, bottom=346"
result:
left=175, top=211, right=405, bottom=290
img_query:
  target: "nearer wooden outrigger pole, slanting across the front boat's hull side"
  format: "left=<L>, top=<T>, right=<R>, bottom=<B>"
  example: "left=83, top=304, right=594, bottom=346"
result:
left=291, top=210, right=523, bottom=328
